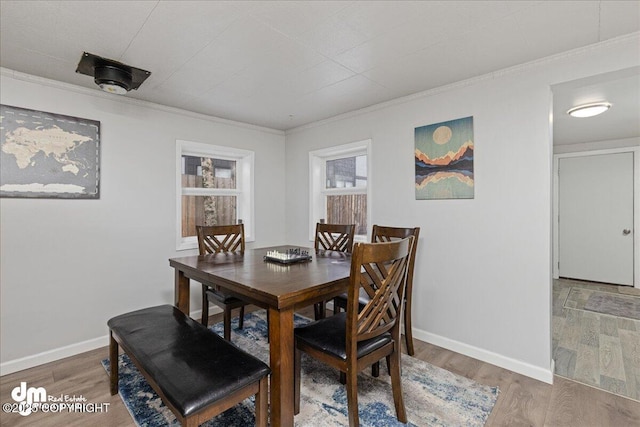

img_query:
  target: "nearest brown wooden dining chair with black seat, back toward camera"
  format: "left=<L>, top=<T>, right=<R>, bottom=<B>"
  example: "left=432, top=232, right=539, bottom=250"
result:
left=294, top=236, right=414, bottom=427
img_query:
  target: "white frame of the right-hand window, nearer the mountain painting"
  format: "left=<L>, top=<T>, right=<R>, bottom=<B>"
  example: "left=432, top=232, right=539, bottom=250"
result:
left=309, top=139, right=372, bottom=242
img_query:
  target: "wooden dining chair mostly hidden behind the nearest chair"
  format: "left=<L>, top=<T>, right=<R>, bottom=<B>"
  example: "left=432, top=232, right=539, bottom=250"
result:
left=333, top=225, right=420, bottom=356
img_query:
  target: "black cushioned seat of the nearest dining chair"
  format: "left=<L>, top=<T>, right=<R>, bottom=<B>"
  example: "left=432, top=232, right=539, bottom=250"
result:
left=294, top=312, right=391, bottom=360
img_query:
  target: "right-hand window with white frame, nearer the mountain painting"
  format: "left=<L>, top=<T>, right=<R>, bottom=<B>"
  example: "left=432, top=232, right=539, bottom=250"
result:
left=309, top=140, right=371, bottom=241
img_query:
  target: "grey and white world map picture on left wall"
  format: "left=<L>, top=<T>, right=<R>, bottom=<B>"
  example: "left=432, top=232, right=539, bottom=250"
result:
left=0, top=105, right=100, bottom=199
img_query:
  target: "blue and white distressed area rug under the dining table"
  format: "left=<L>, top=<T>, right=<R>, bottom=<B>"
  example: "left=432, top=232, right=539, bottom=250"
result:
left=102, top=310, right=499, bottom=427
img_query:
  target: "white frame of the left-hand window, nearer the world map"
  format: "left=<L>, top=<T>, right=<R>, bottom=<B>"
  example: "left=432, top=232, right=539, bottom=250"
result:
left=176, top=140, right=255, bottom=251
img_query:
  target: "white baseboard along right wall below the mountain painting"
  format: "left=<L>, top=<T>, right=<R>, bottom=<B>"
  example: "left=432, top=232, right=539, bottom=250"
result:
left=413, top=328, right=553, bottom=384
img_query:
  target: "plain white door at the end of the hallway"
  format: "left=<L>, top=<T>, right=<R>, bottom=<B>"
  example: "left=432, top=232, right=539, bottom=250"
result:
left=558, top=152, right=634, bottom=286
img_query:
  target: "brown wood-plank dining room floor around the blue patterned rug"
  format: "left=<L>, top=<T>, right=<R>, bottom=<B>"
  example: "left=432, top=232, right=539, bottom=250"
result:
left=0, top=307, right=640, bottom=427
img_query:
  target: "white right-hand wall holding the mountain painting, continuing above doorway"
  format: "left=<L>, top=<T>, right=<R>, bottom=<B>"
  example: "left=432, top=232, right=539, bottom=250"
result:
left=286, top=34, right=640, bottom=382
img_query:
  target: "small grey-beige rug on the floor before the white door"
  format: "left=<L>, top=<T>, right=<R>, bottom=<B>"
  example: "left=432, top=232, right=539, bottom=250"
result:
left=564, top=287, right=640, bottom=320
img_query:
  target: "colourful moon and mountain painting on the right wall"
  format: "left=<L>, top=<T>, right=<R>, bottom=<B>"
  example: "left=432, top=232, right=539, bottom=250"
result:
left=415, top=117, right=474, bottom=200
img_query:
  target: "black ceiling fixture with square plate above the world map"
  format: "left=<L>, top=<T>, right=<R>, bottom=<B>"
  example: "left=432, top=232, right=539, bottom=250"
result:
left=76, top=52, right=151, bottom=95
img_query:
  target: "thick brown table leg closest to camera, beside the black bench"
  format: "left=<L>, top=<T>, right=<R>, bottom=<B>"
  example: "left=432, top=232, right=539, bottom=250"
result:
left=269, top=307, right=294, bottom=427
